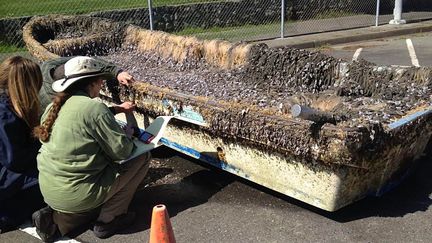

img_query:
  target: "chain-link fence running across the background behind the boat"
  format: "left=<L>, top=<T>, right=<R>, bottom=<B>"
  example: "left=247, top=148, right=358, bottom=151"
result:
left=0, top=0, right=432, bottom=53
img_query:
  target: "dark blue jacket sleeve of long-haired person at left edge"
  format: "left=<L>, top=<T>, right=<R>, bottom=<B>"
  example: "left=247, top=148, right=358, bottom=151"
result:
left=0, top=107, right=40, bottom=173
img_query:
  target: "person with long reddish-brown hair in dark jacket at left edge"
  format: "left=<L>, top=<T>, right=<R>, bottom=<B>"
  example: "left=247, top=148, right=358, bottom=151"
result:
left=0, top=56, right=45, bottom=233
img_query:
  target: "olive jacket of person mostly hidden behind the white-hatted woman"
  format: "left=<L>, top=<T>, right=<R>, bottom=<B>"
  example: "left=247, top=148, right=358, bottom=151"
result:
left=39, top=56, right=121, bottom=111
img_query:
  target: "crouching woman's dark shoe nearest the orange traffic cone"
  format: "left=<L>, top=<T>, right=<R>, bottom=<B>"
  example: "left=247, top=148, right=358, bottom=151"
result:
left=93, top=212, right=135, bottom=239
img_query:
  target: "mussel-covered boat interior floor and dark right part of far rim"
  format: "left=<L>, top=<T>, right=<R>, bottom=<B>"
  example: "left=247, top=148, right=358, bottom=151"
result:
left=104, top=46, right=432, bottom=127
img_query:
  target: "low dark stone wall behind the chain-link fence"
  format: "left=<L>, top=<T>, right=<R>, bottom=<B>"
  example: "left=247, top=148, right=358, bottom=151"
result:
left=91, top=0, right=384, bottom=32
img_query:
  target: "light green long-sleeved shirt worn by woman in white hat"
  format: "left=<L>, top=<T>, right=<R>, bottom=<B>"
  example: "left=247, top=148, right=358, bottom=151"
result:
left=37, top=92, right=134, bottom=213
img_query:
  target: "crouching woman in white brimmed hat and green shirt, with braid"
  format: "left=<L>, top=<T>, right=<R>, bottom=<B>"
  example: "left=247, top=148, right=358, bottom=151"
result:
left=33, top=57, right=150, bottom=241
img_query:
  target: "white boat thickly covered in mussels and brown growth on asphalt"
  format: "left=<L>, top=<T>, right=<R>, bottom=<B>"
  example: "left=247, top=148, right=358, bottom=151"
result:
left=23, top=16, right=432, bottom=211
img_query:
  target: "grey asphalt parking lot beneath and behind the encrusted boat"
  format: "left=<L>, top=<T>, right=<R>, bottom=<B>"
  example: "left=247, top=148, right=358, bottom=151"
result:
left=0, top=33, right=432, bottom=243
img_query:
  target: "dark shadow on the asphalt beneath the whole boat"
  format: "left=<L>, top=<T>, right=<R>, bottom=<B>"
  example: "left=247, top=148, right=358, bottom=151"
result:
left=112, top=142, right=432, bottom=237
